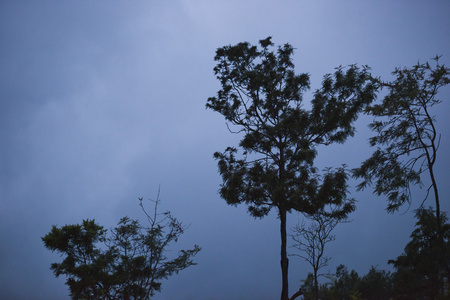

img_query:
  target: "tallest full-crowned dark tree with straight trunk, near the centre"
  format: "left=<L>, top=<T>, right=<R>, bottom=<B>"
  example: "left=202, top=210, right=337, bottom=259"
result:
left=206, top=37, right=376, bottom=300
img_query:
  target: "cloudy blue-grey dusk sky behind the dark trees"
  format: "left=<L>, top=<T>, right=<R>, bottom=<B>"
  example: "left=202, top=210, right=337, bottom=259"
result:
left=0, top=0, right=450, bottom=300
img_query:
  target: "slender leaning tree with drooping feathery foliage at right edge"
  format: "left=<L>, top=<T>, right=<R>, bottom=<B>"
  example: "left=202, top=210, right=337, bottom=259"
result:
left=353, top=57, right=450, bottom=274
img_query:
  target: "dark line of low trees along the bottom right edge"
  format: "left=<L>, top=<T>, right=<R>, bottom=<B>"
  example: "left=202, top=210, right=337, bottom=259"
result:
left=301, top=208, right=450, bottom=300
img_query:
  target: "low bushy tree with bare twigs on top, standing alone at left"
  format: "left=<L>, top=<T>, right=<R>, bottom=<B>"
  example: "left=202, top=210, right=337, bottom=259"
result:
left=42, top=193, right=200, bottom=299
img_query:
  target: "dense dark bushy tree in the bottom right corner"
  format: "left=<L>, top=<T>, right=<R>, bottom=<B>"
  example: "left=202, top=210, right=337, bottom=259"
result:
left=389, top=208, right=450, bottom=299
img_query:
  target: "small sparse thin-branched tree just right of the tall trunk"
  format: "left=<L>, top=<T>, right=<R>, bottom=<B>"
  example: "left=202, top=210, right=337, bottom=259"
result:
left=291, top=206, right=352, bottom=300
